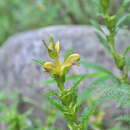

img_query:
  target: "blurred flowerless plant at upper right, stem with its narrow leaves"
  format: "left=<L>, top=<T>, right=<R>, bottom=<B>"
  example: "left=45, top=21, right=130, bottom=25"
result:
left=92, top=0, right=129, bottom=84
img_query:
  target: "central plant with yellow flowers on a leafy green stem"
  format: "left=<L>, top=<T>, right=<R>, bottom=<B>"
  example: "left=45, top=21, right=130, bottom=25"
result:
left=34, top=37, right=106, bottom=130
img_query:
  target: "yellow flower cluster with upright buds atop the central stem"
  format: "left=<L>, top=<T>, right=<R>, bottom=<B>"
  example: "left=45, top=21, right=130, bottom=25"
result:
left=43, top=39, right=80, bottom=76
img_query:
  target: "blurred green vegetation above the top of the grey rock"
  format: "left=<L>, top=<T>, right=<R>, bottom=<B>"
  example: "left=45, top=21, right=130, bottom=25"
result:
left=0, top=0, right=130, bottom=45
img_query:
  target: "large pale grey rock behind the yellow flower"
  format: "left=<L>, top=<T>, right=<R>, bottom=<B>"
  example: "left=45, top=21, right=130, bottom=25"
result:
left=0, top=25, right=130, bottom=127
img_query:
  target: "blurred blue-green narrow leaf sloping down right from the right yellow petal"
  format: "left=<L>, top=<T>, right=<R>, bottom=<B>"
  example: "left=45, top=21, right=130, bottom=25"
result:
left=80, top=61, right=113, bottom=76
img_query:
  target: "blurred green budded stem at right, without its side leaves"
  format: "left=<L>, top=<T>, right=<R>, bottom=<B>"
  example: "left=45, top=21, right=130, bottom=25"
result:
left=104, top=12, right=129, bottom=83
